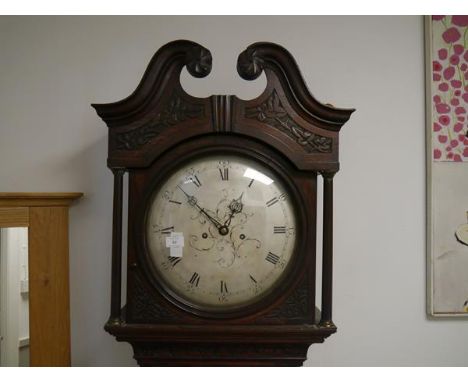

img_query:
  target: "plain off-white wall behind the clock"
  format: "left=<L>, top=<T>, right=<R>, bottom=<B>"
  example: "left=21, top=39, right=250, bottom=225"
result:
left=0, top=17, right=468, bottom=366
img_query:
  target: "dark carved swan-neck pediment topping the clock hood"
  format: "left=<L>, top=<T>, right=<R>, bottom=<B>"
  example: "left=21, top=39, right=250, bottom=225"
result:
left=92, top=40, right=354, bottom=170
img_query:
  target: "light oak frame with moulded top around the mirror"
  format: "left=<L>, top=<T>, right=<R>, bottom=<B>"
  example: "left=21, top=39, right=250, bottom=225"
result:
left=0, top=192, right=83, bottom=366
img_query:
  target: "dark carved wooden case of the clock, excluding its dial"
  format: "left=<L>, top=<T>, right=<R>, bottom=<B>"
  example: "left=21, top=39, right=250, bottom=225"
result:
left=92, top=40, right=354, bottom=366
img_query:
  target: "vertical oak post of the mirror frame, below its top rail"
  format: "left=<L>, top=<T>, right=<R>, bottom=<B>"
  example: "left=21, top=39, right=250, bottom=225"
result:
left=29, top=207, right=70, bottom=366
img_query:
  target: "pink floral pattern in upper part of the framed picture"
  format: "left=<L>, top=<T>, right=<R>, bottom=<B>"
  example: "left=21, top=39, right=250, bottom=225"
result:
left=431, top=15, right=468, bottom=162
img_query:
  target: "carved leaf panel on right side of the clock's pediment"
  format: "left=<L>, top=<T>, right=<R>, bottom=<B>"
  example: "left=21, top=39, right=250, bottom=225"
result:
left=245, top=90, right=333, bottom=153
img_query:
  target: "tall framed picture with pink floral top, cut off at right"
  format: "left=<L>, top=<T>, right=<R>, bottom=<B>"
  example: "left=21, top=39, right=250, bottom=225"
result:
left=425, top=16, right=468, bottom=317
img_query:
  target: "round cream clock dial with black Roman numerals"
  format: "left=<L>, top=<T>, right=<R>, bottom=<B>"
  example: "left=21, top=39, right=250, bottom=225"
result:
left=146, top=155, right=296, bottom=309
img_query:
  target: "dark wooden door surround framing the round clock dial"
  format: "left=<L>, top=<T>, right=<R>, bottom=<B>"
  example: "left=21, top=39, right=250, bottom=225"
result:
left=130, top=135, right=316, bottom=323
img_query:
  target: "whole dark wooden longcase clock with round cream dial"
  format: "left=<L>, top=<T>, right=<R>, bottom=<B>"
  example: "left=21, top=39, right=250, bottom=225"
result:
left=93, top=40, right=353, bottom=366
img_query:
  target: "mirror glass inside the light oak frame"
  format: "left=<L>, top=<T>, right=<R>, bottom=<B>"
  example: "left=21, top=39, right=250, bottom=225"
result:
left=0, top=227, right=29, bottom=366
